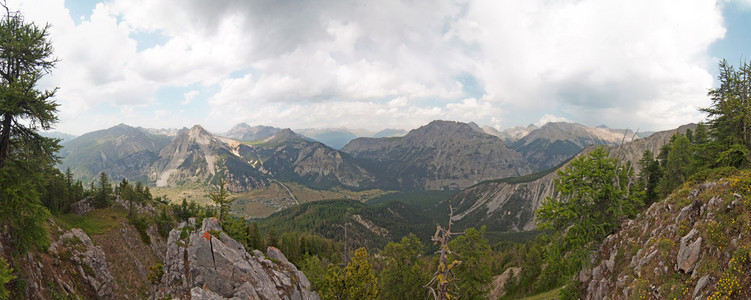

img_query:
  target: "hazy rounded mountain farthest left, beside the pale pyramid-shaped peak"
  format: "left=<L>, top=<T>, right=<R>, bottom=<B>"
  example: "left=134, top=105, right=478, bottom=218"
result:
left=59, top=124, right=170, bottom=182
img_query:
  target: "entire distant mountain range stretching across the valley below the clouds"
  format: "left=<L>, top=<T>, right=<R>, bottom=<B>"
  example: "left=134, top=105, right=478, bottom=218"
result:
left=61, top=121, right=652, bottom=192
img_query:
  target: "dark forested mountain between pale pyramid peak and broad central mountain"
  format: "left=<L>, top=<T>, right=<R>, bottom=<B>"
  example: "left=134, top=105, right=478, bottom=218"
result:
left=234, top=129, right=375, bottom=189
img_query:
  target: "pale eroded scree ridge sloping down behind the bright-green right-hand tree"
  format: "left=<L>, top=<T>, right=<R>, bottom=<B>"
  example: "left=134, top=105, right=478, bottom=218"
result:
left=438, top=124, right=696, bottom=231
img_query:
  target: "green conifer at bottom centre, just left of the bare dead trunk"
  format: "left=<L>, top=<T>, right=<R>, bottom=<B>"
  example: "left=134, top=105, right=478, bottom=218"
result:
left=379, top=234, right=430, bottom=299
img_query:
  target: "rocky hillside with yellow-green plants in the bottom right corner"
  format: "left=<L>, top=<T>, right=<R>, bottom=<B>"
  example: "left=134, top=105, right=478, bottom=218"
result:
left=577, top=169, right=751, bottom=299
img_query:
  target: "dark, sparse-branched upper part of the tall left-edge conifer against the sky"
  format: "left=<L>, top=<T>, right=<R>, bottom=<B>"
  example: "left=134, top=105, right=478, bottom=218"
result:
left=0, top=3, right=59, bottom=168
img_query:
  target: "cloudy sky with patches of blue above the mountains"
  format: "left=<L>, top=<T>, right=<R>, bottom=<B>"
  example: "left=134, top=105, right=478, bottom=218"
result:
left=8, top=0, right=751, bottom=134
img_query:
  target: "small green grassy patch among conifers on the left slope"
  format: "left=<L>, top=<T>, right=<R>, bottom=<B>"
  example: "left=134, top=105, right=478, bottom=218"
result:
left=55, top=207, right=126, bottom=236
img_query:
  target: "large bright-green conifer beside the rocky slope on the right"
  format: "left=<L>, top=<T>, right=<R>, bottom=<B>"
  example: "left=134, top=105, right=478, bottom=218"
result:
left=535, top=147, right=641, bottom=287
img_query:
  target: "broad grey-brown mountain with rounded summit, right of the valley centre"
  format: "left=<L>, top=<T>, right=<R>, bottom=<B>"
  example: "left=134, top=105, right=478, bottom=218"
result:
left=342, top=121, right=529, bottom=190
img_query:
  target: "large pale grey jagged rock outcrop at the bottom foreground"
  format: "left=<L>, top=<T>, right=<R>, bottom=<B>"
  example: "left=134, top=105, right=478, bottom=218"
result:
left=155, top=218, right=319, bottom=300
